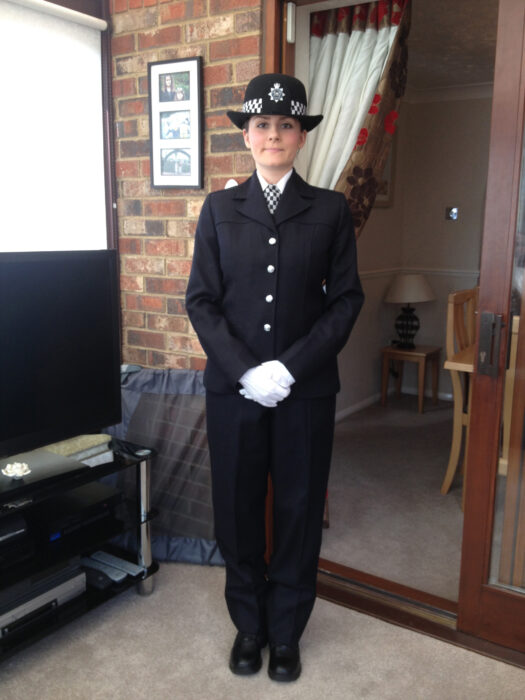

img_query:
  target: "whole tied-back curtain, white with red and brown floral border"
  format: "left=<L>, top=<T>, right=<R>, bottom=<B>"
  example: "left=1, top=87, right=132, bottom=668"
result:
left=307, top=0, right=410, bottom=235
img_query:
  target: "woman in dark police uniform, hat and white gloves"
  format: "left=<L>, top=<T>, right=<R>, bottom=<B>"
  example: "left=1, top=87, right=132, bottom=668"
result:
left=186, top=73, right=363, bottom=681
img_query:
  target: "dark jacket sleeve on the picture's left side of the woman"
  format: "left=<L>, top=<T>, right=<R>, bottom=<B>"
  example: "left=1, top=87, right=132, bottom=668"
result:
left=186, top=195, right=259, bottom=386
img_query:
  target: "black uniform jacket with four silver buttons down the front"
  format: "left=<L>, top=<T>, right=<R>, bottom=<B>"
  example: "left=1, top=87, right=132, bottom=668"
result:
left=186, top=171, right=363, bottom=398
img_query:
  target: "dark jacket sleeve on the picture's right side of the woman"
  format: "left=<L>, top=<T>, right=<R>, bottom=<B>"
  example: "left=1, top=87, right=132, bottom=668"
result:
left=277, top=194, right=364, bottom=381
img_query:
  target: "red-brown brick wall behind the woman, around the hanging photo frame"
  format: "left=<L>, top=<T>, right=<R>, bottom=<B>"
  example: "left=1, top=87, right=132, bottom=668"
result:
left=111, top=0, right=262, bottom=369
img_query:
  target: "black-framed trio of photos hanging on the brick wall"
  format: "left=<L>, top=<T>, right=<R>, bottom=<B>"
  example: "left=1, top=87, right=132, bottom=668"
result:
left=148, top=56, right=203, bottom=188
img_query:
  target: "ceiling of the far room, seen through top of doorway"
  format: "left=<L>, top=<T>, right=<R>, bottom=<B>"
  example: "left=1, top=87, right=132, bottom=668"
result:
left=408, top=0, right=498, bottom=90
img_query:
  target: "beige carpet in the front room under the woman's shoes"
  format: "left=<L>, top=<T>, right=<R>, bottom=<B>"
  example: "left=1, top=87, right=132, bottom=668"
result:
left=0, top=564, right=525, bottom=700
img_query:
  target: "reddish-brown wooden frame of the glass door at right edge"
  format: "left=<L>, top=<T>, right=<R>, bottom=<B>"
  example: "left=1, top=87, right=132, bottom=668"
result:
left=458, top=0, right=525, bottom=651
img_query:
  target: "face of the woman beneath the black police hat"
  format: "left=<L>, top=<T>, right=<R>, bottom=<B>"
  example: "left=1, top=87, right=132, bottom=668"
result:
left=242, top=115, right=306, bottom=184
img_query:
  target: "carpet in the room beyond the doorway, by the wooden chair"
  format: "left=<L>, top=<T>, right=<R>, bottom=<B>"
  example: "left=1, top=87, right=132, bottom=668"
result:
left=321, top=395, right=463, bottom=600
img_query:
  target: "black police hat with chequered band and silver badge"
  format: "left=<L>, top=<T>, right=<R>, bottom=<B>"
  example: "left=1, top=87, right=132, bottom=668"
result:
left=226, top=73, right=323, bottom=131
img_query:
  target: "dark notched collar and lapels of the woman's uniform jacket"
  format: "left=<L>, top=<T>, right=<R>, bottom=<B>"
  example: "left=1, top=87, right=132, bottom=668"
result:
left=233, top=170, right=314, bottom=229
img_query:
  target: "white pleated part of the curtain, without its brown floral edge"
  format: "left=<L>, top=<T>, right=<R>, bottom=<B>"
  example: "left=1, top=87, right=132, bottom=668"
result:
left=307, top=2, right=398, bottom=189
